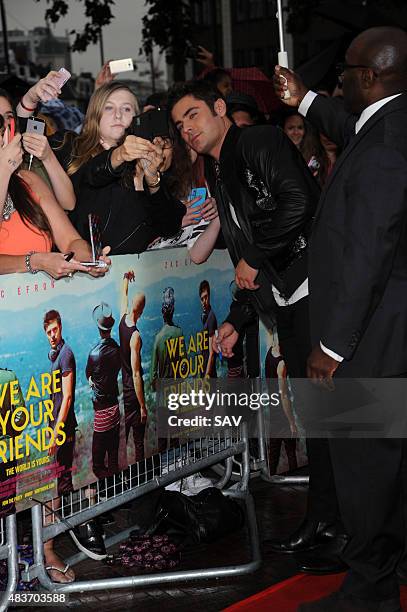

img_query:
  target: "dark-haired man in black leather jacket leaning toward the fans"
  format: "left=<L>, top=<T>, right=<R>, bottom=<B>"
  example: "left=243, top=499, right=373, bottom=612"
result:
left=168, top=81, right=344, bottom=552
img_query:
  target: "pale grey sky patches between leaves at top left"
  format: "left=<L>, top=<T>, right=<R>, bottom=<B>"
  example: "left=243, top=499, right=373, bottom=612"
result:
left=4, top=0, right=165, bottom=80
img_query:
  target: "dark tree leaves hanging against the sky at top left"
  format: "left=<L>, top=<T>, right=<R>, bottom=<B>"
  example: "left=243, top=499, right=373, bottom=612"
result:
left=36, top=0, right=115, bottom=51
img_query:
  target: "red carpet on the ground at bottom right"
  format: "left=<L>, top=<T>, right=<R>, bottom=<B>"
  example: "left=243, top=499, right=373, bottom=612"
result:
left=223, top=574, right=407, bottom=612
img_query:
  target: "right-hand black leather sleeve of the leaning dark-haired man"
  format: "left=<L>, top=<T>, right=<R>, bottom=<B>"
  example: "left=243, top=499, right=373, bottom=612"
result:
left=239, top=126, right=320, bottom=269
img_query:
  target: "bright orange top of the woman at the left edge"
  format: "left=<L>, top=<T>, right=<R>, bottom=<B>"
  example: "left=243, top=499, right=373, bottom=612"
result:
left=0, top=192, right=52, bottom=255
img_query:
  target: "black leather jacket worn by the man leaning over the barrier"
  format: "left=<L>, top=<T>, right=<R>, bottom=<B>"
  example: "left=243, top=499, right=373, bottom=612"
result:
left=213, top=125, right=320, bottom=328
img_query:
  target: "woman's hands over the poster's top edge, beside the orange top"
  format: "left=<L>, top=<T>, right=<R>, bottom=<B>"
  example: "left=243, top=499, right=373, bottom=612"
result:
left=30, top=247, right=112, bottom=279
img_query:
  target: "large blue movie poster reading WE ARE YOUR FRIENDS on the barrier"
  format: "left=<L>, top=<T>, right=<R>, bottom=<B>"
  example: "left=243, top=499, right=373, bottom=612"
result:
left=0, top=248, right=233, bottom=513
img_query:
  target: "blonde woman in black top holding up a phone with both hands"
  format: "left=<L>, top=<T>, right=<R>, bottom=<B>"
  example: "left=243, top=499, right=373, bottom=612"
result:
left=67, top=82, right=185, bottom=254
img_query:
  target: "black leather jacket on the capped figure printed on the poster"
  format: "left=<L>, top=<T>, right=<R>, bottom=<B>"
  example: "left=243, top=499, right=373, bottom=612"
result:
left=86, top=338, right=121, bottom=410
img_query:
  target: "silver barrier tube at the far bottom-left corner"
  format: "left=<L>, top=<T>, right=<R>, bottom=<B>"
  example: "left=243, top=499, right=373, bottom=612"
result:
left=0, top=514, right=18, bottom=612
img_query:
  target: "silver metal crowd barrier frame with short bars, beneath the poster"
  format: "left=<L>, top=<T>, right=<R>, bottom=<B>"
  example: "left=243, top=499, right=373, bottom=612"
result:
left=24, top=425, right=261, bottom=593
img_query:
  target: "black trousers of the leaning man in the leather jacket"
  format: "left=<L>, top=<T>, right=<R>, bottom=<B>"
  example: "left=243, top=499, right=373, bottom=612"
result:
left=276, top=297, right=339, bottom=522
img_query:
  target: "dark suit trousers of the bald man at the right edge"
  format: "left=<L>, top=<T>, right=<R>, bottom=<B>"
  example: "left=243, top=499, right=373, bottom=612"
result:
left=329, top=439, right=406, bottom=599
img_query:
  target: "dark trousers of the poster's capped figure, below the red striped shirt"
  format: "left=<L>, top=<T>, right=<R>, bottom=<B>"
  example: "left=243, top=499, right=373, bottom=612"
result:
left=92, top=425, right=120, bottom=480
